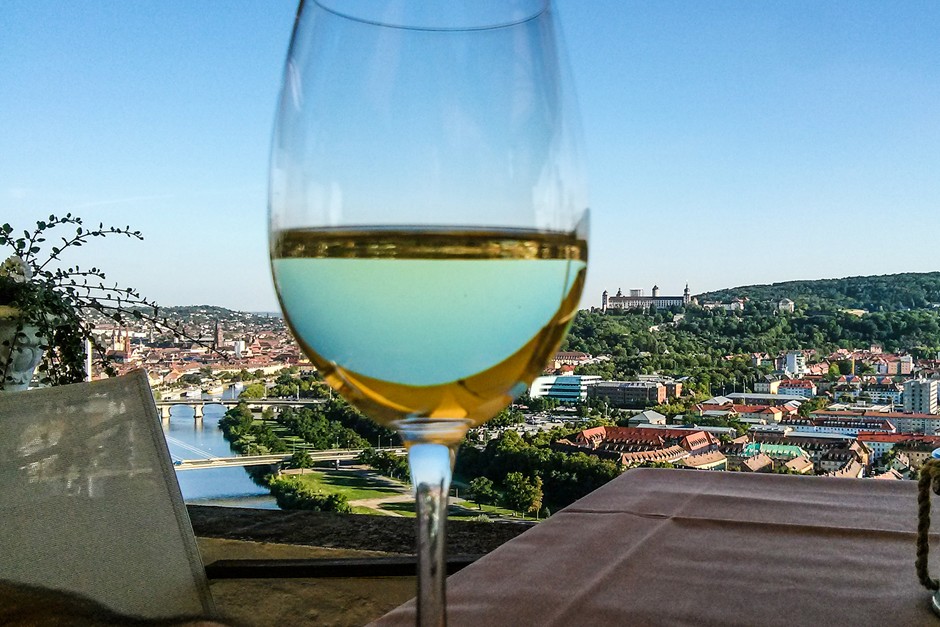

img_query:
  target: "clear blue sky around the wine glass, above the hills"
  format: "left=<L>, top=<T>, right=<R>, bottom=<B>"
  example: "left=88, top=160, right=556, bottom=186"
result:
left=0, top=0, right=940, bottom=311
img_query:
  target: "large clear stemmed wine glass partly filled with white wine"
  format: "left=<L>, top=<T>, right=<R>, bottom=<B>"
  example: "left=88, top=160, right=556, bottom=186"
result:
left=269, top=0, right=587, bottom=625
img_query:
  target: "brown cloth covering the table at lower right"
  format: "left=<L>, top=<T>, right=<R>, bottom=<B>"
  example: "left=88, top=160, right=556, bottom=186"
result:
left=376, top=469, right=940, bottom=627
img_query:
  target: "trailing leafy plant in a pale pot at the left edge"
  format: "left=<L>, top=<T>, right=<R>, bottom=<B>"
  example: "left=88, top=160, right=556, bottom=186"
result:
left=0, top=214, right=192, bottom=391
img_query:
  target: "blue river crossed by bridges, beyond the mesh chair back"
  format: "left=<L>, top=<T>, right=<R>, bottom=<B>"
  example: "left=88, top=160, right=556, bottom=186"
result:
left=163, top=389, right=277, bottom=509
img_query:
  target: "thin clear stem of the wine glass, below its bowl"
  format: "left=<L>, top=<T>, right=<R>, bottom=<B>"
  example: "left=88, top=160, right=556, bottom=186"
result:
left=408, top=443, right=454, bottom=627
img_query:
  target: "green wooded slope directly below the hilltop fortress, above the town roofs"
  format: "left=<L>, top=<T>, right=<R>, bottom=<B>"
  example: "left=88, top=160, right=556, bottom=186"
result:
left=563, top=301, right=940, bottom=392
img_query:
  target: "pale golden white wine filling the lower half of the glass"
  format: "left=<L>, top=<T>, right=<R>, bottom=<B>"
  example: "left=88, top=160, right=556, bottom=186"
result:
left=272, top=228, right=587, bottom=427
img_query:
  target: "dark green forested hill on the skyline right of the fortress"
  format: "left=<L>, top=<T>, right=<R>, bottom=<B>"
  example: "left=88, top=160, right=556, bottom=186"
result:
left=697, top=272, right=940, bottom=311
